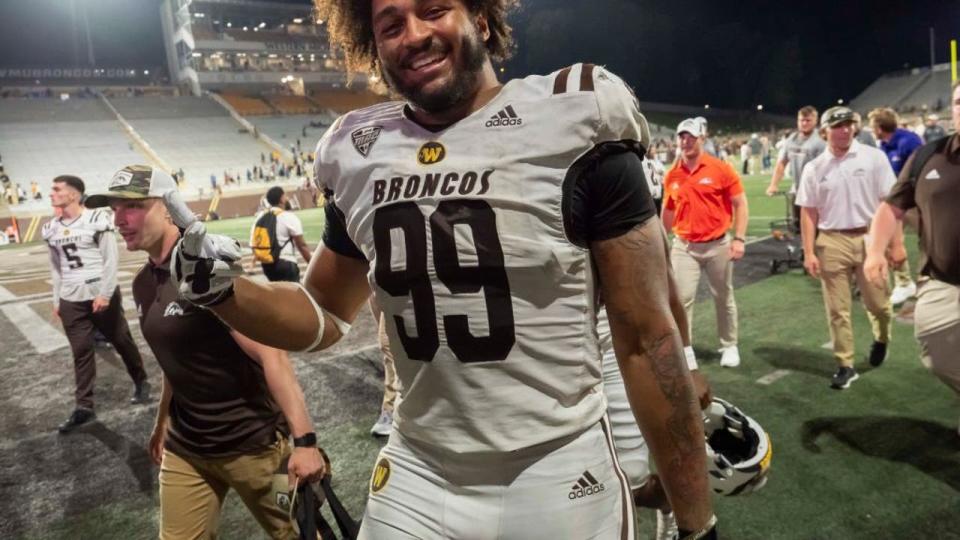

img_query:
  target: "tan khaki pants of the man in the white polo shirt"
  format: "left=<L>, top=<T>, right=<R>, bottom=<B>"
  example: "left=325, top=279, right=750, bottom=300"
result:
left=815, top=231, right=893, bottom=367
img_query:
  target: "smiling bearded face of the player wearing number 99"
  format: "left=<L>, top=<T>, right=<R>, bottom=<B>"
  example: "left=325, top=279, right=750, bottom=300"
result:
left=373, top=0, right=489, bottom=113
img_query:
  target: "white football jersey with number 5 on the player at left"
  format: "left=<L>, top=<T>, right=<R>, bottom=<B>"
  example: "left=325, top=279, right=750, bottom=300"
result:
left=41, top=209, right=113, bottom=302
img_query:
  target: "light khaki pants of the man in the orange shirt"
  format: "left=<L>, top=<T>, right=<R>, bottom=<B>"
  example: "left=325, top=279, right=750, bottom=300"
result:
left=670, top=236, right=737, bottom=347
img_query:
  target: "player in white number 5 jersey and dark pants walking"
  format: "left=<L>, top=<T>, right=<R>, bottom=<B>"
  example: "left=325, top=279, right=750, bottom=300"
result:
left=41, top=175, right=150, bottom=433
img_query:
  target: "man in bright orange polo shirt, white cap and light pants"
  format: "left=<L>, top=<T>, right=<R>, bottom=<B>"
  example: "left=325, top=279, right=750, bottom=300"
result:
left=662, top=118, right=747, bottom=367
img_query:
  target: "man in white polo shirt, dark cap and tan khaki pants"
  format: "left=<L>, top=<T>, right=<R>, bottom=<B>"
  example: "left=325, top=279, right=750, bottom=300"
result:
left=797, top=107, right=903, bottom=390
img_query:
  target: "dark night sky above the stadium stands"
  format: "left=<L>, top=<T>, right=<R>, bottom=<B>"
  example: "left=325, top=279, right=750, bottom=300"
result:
left=0, top=0, right=960, bottom=112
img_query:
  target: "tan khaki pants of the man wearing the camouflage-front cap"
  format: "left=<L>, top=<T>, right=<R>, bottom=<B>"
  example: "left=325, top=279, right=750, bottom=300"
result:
left=160, top=435, right=296, bottom=540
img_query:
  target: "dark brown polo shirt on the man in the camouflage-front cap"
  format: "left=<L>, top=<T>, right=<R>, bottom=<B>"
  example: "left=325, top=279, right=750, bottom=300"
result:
left=133, top=261, right=288, bottom=458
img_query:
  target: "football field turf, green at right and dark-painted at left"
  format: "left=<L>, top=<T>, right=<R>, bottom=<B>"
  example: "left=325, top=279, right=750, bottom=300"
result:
left=0, top=171, right=960, bottom=540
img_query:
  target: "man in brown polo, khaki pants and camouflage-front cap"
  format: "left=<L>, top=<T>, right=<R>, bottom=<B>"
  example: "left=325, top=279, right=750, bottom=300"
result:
left=87, top=165, right=324, bottom=539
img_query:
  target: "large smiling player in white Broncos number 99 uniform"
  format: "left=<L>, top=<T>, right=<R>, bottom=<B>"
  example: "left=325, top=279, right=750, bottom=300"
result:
left=168, top=0, right=716, bottom=539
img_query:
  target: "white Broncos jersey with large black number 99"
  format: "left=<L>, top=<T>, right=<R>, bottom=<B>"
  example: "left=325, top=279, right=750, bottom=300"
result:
left=316, top=64, right=649, bottom=452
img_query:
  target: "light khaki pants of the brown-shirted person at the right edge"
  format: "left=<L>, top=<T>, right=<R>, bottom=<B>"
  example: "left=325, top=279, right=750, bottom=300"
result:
left=914, top=278, right=960, bottom=395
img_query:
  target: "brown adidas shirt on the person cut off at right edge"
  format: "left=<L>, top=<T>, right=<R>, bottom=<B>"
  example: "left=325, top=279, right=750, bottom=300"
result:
left=887, top=135, right=960, bottom=285
